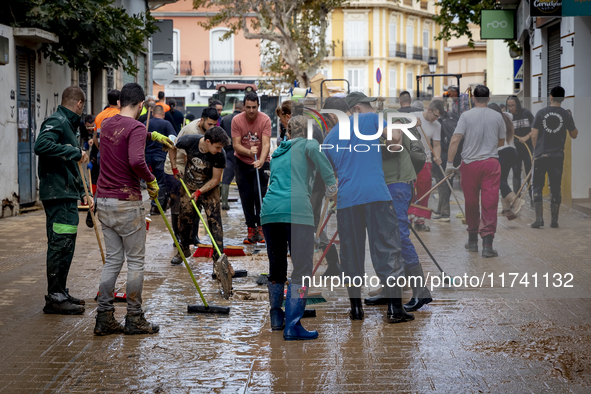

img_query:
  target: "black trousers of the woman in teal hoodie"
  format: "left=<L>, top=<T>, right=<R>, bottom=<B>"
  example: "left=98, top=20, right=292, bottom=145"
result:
left=263, top=223, right=314, bottom=286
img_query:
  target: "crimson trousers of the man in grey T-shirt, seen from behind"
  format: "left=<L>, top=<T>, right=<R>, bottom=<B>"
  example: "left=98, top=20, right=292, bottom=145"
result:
left=460, top=157, right=501, bottom=238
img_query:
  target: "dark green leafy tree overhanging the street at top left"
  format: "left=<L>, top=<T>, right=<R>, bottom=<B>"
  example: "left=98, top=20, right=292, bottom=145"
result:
left=0, top=0, right=158, bottom=74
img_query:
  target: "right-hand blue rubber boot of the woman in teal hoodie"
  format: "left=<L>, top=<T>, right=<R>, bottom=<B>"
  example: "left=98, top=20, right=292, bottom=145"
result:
left=283, top=283, right=318, bottom=341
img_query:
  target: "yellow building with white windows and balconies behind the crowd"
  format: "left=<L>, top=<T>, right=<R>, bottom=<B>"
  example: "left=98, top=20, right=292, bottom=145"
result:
left=320, top=0, right=444, bottom=102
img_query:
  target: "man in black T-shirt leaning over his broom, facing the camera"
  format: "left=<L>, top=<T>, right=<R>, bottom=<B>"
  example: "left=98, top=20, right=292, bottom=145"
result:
left=170, top=126, right=230, bottom=265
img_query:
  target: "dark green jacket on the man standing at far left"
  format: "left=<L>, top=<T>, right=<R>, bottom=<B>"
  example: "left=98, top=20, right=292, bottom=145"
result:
left=35, top=105, right=85, bottom=201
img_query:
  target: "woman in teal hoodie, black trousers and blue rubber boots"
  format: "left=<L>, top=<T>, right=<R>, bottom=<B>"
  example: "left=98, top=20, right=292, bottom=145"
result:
left=261, top=115, right=337, bottom=341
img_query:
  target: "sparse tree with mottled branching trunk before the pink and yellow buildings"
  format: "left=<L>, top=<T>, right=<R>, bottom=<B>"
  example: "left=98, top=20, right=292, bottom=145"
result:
left=193, top=0, right=346, bottom=87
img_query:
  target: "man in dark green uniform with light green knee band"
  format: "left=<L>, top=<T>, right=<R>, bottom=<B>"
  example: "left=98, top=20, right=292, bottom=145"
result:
left=35, top=86, right=94, bottom=315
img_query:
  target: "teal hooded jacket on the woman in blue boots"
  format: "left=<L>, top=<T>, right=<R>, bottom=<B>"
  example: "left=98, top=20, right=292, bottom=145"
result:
left=261, top=138, right=336, bottom=226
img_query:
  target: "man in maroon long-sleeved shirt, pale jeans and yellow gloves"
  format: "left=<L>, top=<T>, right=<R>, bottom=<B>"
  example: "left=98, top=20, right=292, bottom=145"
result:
left=94, top=83, right=173, bottom=335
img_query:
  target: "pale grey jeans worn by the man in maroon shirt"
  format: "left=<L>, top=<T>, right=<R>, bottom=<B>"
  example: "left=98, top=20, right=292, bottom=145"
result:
left=97, top=198, right=146, bottom=315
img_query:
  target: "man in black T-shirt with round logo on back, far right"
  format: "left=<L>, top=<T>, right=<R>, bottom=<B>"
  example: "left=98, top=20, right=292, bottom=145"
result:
left=531, top=86, right=579, bottom=228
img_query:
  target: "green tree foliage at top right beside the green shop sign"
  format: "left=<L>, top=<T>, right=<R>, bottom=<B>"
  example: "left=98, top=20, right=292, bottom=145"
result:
left=433, top=0, right=521, bottom=53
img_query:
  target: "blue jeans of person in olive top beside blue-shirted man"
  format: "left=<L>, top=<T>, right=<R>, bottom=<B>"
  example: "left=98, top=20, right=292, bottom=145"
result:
left=388, top=183, right=419, bottom=270
